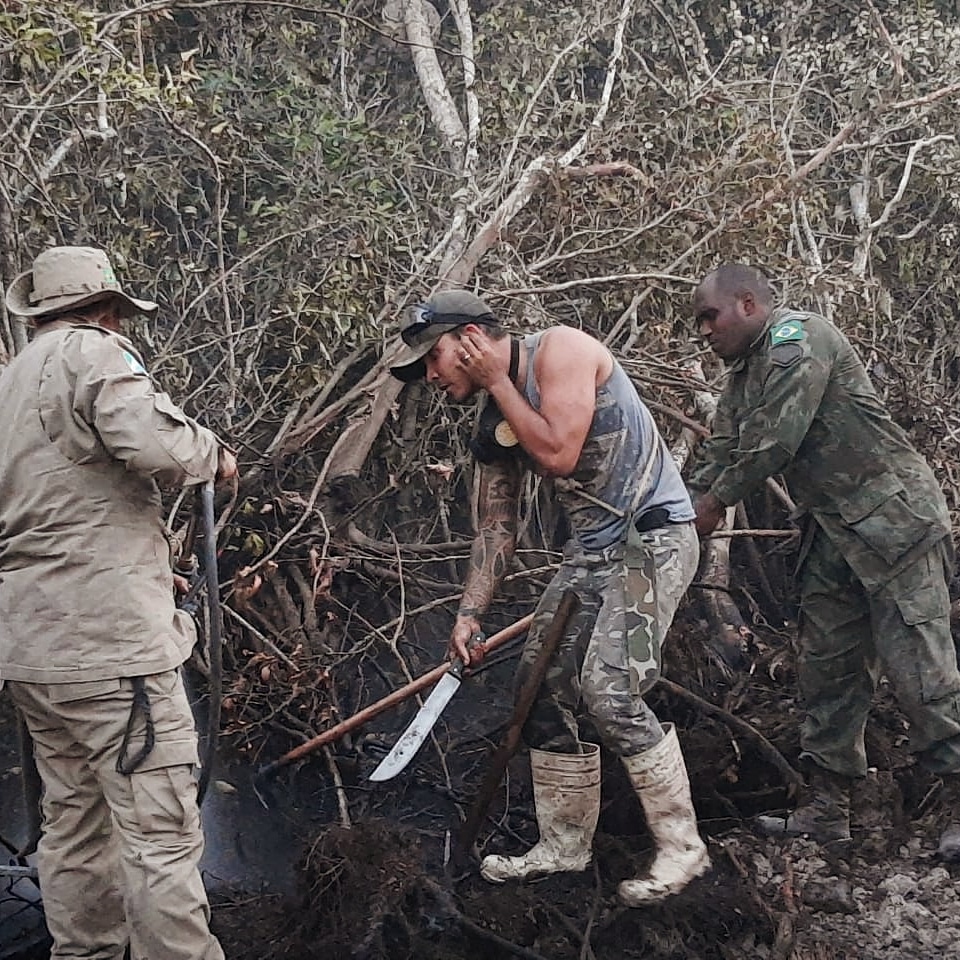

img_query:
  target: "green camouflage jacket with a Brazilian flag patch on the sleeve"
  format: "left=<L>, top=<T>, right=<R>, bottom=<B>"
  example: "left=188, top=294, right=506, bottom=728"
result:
left=688, top=310, right=950, bottom=592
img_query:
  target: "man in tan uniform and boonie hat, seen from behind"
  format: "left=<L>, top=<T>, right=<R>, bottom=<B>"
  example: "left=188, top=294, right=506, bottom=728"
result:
left=0, top=247, right=236, bottom=960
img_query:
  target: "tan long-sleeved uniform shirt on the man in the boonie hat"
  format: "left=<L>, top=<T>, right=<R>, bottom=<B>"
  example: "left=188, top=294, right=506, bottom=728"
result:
left=0, top=321, right=219, bottom=683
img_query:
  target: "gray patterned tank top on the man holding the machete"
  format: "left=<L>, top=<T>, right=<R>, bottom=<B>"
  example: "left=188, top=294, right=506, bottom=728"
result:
left=523, top=331, right=696, bottom=552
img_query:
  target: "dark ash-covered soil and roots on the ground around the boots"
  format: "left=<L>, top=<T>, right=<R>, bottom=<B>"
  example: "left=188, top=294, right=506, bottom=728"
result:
left=206, top=621, right=960, bottom=960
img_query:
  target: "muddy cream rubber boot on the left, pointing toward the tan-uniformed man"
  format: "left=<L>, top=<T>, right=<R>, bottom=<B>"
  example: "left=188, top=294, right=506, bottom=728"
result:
left=480, top=743, right=600, bottom=883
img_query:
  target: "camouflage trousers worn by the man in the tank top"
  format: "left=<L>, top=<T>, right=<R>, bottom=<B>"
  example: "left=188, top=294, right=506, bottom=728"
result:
left=517, top=522, right=700, bottom=757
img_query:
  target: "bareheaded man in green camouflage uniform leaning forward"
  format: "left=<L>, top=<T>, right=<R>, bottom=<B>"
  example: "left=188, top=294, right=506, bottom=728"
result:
left=689, top=264, right=960, bottom=860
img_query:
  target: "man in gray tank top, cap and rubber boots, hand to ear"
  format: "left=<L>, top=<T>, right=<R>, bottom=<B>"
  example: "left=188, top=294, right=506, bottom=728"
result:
left=391, top=290, right=710, bottom=906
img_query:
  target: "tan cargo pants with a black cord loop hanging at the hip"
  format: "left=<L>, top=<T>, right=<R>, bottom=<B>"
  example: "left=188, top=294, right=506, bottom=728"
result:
left=7, top=670, right=223, bottom=960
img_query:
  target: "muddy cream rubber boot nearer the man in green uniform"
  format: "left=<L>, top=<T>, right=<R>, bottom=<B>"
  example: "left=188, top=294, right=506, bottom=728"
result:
left=617, top=723, right=710, bottom=907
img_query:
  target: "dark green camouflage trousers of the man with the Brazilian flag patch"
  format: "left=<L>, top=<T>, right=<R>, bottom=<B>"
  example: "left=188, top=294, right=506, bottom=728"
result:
left=798, top=527, right=960, bottom=777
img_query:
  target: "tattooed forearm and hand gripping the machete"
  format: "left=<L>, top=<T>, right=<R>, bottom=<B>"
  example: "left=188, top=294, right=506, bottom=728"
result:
left=447, top=462, right=522, bottom=663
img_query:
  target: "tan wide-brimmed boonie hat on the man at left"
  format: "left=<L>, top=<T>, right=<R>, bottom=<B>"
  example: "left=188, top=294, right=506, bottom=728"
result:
left=6, top=247, right=157, bottom=317
